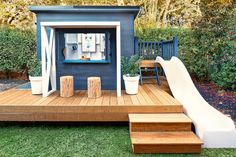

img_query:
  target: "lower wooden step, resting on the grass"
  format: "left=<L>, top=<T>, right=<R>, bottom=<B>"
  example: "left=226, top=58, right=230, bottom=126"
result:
left=130, top=131, right=203, bottom=153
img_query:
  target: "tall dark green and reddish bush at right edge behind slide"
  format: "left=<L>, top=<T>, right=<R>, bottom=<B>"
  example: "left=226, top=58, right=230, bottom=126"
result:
left=195, top=1, right=236, bottom=90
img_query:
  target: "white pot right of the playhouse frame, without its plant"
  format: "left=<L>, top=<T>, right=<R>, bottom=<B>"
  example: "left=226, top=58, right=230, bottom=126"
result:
left=123, top=75, right=140, bottom=94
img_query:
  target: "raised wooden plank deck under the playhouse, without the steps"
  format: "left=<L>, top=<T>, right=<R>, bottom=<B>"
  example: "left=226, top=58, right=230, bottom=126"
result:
left=0, top=81, right=183, bottom=122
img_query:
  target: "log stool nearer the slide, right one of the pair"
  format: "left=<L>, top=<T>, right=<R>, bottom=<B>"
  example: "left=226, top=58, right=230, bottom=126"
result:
left=87, top=77, right=102, bottom=98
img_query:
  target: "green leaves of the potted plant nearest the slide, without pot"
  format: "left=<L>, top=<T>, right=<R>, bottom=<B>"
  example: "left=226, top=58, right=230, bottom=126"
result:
left=121, top=55, right=140, bottom=77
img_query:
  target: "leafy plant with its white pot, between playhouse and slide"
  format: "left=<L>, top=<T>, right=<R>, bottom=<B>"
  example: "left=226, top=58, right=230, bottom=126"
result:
left=121, top=55, right=140, bottom=94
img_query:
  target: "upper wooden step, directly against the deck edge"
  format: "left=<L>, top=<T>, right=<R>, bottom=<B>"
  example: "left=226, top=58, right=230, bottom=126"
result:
left=129, top=113, right=192, bottom=132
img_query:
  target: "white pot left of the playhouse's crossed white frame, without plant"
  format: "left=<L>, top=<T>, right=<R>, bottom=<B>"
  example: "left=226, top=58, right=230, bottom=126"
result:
left=29, top=76, right=43, bottom=94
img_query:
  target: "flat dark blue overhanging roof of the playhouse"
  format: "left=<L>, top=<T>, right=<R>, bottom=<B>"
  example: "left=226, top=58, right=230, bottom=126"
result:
left=29, top=6, right=140, bottom=17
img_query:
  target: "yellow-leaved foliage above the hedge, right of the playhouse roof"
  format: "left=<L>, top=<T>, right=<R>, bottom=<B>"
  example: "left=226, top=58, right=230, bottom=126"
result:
left=136, top=0, right=201, bottom=28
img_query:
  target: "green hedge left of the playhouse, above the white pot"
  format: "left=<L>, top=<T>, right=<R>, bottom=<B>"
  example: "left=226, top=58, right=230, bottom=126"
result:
left=0, top=27, right=37, bottom=78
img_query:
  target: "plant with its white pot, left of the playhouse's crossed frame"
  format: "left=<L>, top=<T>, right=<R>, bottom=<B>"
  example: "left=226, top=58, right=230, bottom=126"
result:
left=29, top=60, right=42, bottom=94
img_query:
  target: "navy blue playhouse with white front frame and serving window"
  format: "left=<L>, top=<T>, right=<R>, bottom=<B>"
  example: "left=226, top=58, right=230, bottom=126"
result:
left=29, top=6, right=177, bottom=96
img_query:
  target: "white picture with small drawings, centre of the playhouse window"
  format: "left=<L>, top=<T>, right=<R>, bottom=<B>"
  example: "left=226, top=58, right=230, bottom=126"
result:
left=82, top=33, right=96, bottom=52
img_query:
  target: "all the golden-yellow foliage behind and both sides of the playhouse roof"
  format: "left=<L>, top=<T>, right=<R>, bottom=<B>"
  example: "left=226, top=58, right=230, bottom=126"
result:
left=0, top=0, right=201, bottom=29
